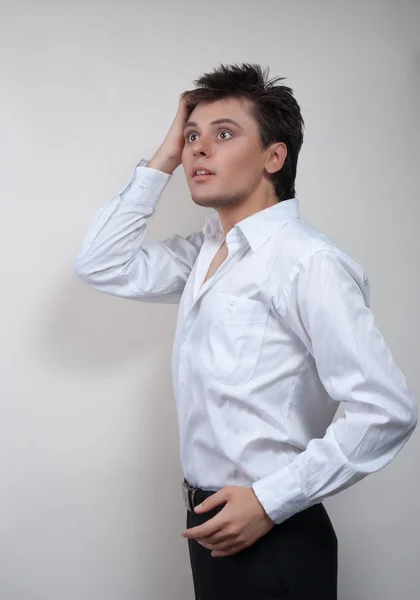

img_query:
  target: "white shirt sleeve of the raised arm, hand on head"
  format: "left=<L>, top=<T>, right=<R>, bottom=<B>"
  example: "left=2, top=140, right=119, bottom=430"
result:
left=74, top=160, right=203, bottom=304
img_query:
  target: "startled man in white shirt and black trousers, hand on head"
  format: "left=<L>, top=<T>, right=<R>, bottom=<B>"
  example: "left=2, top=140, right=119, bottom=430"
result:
left=75, top=64, right=417, bottom=600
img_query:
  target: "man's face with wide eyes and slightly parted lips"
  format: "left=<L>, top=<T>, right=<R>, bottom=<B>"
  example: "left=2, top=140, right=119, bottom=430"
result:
left=182, top=98, right=265, bottom=208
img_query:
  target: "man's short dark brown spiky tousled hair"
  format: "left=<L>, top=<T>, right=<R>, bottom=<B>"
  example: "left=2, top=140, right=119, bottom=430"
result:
left=184, top=63, right=305, bottom=202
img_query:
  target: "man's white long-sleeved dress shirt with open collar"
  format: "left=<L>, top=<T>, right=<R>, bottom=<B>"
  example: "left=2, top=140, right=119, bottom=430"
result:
left=74, top=161, right=417, bottom=523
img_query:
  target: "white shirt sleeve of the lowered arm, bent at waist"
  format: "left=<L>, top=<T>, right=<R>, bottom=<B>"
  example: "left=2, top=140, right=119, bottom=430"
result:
left=252, top=250, right=417, bottom=523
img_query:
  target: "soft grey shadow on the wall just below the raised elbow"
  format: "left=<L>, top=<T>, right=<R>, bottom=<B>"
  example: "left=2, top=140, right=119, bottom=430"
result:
left=43, top=274, right=178, bottom=369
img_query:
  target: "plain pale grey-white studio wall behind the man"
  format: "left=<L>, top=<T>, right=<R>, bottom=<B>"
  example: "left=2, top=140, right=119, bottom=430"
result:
left=0, top=0, right=420, bottom=600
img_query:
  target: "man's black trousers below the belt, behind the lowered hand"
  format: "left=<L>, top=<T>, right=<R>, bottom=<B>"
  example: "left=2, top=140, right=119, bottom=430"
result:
left=187, top=482, right=338, bottom=600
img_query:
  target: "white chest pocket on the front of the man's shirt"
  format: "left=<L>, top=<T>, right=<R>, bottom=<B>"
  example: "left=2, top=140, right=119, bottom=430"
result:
left=197, top=292, right=268, bottom=385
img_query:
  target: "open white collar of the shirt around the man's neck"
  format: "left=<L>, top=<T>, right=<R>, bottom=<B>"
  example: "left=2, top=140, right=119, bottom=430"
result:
left=202, top=198, right=300, bottom=252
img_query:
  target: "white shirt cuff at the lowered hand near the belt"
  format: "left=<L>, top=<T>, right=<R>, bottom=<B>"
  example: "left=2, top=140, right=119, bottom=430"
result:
left=252, top=462, right=310, bottom=524
